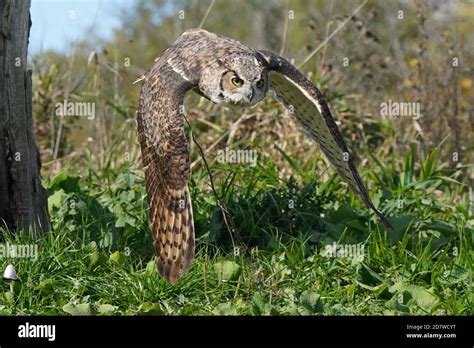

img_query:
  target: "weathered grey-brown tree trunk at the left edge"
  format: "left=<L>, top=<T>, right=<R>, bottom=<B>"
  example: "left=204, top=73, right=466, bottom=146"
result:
left=0, top=0, right=49, bottom=235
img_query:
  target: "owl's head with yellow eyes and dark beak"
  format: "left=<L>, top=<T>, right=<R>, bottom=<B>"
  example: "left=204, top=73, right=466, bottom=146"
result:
left=199, top=55, right=268, bottom=106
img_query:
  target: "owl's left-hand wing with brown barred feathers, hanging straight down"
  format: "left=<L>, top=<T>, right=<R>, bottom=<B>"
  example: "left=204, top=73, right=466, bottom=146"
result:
left=137, top=61, right=194, bottom=284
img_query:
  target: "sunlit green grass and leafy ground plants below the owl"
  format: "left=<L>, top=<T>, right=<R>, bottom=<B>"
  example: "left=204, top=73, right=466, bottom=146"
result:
left=0, top=150, right=474, bottom=315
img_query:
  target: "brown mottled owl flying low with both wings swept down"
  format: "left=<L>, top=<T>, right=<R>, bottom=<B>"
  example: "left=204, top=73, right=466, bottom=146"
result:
left=137, top=29, right=391, bottom=284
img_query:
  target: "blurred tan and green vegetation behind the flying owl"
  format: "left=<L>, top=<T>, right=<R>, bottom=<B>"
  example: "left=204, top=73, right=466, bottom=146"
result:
left=31, top=0, right=474, bottom=181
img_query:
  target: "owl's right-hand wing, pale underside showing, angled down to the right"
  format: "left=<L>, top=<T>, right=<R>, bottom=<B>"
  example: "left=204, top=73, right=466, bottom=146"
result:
left=259, top=51, right=393, bottom=229
